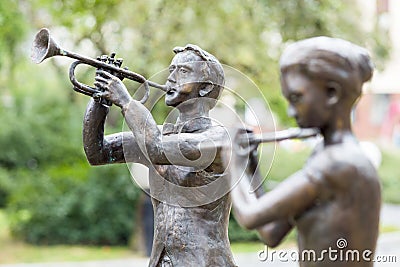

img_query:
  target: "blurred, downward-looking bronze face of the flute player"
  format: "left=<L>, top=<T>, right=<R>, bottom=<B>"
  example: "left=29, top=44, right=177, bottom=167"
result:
left=281, top=70, right=333, bottom=128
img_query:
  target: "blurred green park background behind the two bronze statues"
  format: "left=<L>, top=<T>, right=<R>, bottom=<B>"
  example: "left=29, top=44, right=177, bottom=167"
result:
left=0, top=0, right=400, bottom=264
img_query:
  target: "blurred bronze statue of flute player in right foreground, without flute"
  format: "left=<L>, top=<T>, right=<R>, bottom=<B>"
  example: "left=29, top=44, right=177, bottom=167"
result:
left=228, top=37, right=381, bottom=267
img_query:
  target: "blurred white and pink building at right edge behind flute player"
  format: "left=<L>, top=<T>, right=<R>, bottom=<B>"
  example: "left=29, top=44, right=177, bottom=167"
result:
left=353, top=0, right=400, bottom=147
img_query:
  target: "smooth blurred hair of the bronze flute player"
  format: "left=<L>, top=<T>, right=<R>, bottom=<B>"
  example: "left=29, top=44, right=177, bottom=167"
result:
left=280, top=36, right=374, bottom=101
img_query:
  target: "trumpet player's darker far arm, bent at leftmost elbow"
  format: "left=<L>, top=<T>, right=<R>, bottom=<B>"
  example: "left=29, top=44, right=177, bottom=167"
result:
left=83, top=99, right=146, bottom=165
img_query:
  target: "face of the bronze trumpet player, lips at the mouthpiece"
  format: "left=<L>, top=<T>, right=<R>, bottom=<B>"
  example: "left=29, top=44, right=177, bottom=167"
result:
left=165, top=51, right=207, bottom=107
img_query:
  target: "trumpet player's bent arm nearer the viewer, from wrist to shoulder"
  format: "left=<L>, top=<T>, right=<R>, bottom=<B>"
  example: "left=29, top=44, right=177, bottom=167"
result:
left=122, top=99, right=222, bottom=167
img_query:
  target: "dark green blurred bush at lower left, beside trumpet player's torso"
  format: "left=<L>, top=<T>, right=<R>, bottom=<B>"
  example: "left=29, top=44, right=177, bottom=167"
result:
left=8, top=162, right=140, bottom=245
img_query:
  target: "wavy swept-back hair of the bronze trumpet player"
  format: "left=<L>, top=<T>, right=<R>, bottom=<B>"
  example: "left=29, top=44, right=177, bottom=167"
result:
left=173, top=44, right=225, bottom=104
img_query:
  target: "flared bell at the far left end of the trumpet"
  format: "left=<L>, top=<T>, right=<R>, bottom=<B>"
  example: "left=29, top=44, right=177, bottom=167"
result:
left=31, top=28, right=61, bottom=64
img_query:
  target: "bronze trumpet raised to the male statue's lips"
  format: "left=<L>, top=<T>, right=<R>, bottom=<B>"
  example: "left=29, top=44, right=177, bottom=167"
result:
left=31, top=28, right=167, bottom=106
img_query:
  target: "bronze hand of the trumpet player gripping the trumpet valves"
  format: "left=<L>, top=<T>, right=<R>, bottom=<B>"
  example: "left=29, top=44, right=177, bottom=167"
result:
left=94, top=70, right=132, bottom=108
